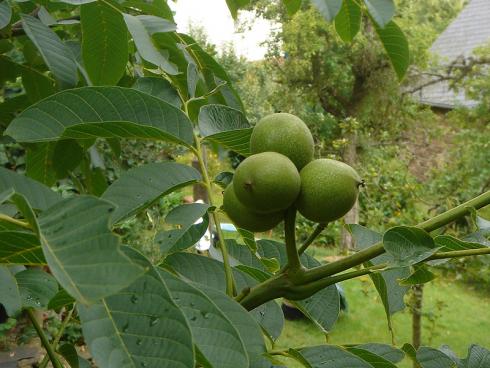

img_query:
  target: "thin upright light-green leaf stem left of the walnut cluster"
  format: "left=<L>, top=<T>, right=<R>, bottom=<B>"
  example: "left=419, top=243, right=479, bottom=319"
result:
left=194, top=133, right=236, bottom=297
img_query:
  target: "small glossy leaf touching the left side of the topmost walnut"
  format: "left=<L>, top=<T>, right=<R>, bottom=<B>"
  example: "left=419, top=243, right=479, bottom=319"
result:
left=199, top=105, right=252, bottom=156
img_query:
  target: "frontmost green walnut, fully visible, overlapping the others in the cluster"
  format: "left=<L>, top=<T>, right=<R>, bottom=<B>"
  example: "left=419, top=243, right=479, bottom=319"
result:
left=233, top=152, right=301, bottom=213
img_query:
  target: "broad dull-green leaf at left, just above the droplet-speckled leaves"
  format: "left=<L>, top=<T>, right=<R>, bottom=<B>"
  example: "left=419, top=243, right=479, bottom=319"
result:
left=38, top=196, right=143, bottom=304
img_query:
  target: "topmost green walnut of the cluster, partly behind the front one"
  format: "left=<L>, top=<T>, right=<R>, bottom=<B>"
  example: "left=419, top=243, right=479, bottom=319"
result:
left=250, top=113, right=315, bottom=170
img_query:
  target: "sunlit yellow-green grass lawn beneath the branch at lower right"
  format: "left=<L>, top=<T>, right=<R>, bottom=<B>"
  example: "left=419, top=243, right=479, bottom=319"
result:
left=276, top=268, right=490, bottom=368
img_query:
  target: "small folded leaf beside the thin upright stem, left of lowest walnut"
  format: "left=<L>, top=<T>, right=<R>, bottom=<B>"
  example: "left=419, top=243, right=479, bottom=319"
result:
left=155, top=203, right=209, bottom=254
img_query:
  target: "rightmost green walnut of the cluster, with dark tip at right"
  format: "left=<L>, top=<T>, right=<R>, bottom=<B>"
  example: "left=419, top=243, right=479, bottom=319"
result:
left=296, top=159, right=362, bottom=222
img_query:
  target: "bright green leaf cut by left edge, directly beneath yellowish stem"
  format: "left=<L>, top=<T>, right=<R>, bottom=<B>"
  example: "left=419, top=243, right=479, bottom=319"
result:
left=0, top=231, right=46, bottom=266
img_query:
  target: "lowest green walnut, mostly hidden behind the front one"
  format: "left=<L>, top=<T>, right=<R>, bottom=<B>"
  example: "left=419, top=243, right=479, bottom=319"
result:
left=223, top=183, right=283, bottom=232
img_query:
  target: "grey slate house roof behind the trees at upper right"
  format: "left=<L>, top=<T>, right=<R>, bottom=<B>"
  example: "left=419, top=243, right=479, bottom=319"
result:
left=418, top=0, right=490, bottom=108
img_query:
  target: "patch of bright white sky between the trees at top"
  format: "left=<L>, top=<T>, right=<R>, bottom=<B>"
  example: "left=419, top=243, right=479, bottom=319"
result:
left=169, top=0, right=271, bottom=60
